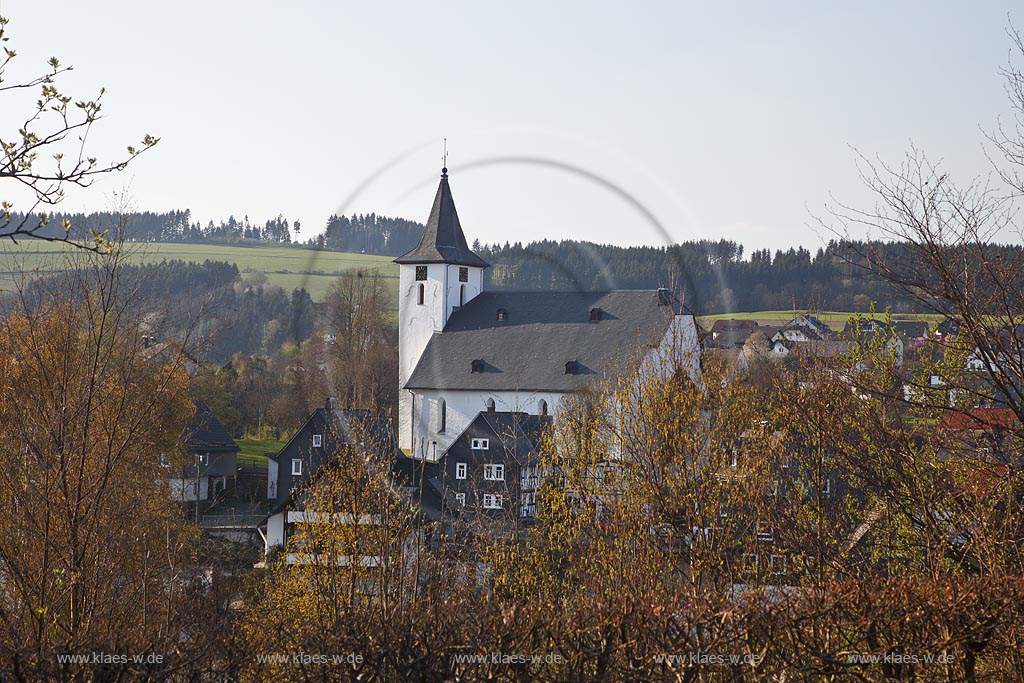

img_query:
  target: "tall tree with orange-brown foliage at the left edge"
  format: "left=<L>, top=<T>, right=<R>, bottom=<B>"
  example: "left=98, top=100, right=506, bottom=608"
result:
left=0, top=244, right=237, bottom=681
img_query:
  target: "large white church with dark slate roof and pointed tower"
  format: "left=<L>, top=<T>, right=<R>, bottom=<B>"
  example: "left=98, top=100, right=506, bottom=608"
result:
left=395, top=168, right=700, bottom=462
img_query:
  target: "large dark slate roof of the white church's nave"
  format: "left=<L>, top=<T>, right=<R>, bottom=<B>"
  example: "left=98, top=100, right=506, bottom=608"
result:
left=406, top=290, right=682, bottom=392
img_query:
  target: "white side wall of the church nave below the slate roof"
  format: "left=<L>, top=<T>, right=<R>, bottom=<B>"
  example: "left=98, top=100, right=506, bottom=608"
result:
left=411, top=389, right=566, bottom=460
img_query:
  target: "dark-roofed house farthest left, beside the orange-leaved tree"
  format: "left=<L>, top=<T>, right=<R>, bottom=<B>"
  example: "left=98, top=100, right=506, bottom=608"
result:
left=167, top=400, right=239, bottom=502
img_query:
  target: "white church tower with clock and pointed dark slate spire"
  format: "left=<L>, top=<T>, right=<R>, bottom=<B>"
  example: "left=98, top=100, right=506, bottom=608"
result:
left=394, top=168, right=488, bottom=454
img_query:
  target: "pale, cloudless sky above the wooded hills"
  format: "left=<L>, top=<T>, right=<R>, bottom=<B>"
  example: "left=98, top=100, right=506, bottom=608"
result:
left=0, top=0, right=1024, bottom=253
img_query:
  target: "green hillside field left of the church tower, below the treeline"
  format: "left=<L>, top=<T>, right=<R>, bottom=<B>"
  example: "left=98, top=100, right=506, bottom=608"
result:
left=0, top=240, right=398, bottom=301
